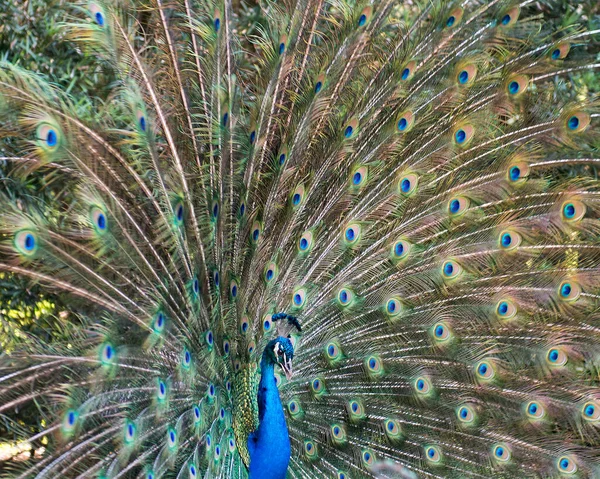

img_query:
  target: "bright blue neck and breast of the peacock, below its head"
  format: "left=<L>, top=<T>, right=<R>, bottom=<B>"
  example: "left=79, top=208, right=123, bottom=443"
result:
left=248, top=353, right=291, bottom=479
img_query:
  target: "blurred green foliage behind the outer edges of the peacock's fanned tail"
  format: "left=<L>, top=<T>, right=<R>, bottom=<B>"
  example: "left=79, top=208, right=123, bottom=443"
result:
left=0, top=0, right=600, bottom=460
